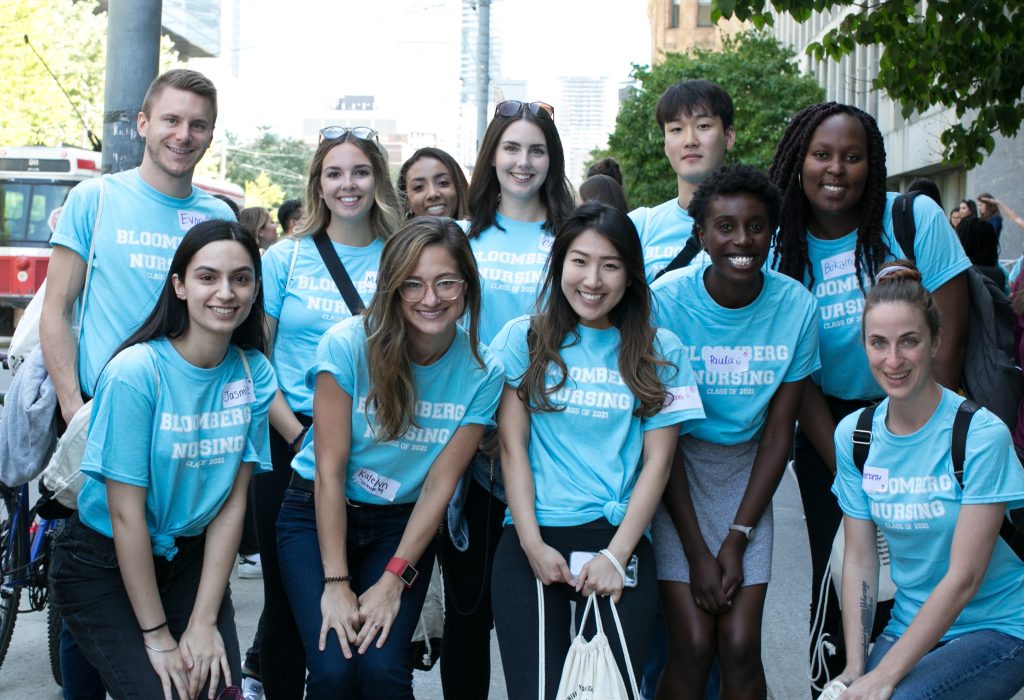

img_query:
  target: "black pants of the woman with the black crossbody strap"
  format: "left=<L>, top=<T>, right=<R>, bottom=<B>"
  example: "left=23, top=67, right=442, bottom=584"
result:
left=247, top=413, right=312, bottom=700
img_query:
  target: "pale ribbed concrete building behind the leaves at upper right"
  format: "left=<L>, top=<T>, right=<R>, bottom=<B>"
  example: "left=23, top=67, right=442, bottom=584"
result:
left=773, top=10, right=1024, bottom=259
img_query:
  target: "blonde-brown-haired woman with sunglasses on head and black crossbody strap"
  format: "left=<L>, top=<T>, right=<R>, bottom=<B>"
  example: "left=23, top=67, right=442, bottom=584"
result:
left=244, top=127, right=401, bottom=700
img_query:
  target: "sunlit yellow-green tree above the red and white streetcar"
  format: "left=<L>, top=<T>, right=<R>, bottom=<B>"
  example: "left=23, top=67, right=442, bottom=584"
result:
left=0, top=0, right=179, bottom=147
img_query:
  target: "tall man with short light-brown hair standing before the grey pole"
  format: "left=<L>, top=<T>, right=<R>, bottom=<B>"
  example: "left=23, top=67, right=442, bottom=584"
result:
left=39, top=70, right=234, bottom=700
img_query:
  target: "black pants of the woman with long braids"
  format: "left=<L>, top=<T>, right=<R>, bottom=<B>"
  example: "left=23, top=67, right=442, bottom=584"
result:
left=794, top=396, right=893, bottom=697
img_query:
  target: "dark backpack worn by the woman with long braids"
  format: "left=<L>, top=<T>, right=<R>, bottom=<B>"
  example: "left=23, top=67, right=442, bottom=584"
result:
left=892, top=192, right=1024, bottom=430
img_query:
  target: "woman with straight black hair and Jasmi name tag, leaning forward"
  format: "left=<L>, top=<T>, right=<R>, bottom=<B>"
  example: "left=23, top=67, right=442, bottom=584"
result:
left=49, top=219, right=276, bottom=700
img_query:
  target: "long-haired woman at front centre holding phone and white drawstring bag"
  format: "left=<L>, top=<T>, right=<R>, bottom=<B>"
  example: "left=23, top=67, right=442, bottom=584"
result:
left=492, top=202, right=703, bottom=700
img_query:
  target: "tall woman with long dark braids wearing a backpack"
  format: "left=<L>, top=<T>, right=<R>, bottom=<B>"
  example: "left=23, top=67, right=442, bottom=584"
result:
left=768, top=102, right=971, bottom=691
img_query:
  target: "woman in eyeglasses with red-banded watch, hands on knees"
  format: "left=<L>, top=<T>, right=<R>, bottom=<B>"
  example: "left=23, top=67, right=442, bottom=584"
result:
left=278, top=217, right=502, bottom=700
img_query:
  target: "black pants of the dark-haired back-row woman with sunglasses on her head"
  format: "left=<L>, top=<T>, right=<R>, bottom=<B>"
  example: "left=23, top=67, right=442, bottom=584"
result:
left=437, top=478, right=505, bottom=700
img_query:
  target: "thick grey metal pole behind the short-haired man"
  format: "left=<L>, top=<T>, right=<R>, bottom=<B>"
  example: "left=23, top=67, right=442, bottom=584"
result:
left=103, top=0, right=163, bottom=173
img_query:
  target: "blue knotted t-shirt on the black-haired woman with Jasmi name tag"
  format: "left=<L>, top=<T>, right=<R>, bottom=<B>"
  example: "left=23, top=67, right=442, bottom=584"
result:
left=78, top=338, right=278, bottom=559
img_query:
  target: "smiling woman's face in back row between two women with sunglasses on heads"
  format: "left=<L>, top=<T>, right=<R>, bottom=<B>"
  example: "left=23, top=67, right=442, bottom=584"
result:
left=396, top=147, right=469, bottom=219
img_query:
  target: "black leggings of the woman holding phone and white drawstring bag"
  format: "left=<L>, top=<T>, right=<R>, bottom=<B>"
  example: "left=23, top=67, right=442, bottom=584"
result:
left=492, top=520, right=657, bottom=700
